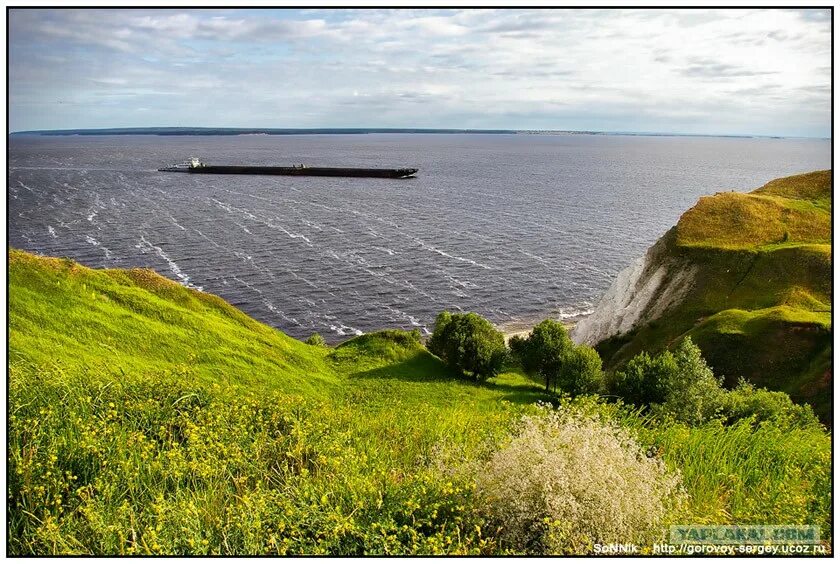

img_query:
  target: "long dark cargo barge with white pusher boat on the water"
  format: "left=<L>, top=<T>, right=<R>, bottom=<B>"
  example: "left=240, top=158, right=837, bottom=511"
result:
left=158, top=158, right=417, bottom=178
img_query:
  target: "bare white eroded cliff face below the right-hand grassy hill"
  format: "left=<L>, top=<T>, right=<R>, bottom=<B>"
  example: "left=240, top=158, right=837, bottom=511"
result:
left=571, top=229, right=698, bottom=345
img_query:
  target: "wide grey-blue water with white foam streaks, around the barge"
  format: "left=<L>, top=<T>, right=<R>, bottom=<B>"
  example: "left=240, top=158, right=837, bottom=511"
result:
left=8, top=134, right=831, bottom=342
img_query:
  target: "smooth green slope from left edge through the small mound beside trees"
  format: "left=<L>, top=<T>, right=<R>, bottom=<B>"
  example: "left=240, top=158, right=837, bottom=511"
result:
left=9, top=249, right=542, bottom=410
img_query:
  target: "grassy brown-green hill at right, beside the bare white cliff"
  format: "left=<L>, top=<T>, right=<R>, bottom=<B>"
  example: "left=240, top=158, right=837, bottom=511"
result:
left=598, top=171, right=832, bottom=421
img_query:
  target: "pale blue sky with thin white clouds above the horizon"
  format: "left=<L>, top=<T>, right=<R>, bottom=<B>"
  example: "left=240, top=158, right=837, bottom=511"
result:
left=8, top=9, right=831, bottom=137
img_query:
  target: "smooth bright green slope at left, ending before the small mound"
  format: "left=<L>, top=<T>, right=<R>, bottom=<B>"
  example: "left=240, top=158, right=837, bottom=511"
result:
left=9, top=249, right=336, bottom=394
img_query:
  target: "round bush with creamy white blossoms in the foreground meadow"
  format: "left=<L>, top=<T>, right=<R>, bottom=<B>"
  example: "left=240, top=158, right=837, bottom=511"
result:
left=477, top=408, right=683, bottom=554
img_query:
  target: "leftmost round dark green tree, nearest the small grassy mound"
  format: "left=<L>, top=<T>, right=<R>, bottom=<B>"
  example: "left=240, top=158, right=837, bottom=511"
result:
left=428, top=312, right=507, bottom=380
